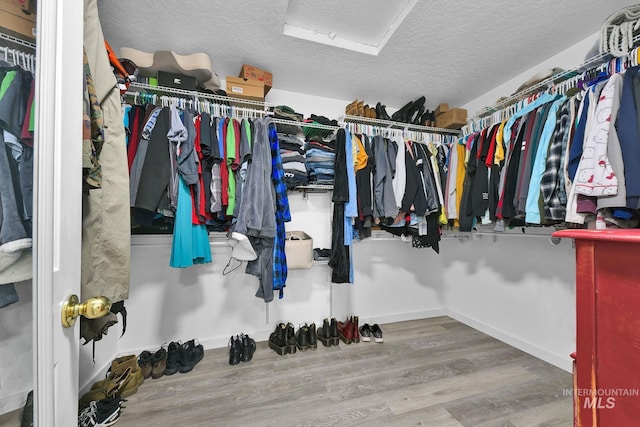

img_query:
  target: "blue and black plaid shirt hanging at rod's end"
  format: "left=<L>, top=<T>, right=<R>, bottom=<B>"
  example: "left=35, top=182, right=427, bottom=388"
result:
left=265, top=118, right=291, bottom=299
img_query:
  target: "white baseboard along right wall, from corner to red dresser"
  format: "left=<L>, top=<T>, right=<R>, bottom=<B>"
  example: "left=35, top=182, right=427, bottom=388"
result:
left=446, top=309, right=572, bottom=372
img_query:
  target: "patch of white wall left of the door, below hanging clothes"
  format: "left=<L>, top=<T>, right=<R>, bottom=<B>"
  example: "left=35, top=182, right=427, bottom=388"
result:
left=0, top=280, right=33, bottom=414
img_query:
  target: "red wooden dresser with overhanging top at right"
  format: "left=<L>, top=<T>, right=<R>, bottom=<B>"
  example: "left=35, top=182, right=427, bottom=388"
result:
left=553, top=229, right=640, bottom=427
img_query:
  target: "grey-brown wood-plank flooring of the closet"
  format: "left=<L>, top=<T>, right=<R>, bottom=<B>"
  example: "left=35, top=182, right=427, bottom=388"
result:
left=0, top=317, right=573, bottom=427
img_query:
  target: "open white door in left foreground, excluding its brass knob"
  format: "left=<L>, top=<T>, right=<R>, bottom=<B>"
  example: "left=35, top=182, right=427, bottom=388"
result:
left=33, top=0, right=83, bottom=426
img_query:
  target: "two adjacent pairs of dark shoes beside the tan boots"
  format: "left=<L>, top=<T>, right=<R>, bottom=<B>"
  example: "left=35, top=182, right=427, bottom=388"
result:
left=138, top=338, right=204, bottom=379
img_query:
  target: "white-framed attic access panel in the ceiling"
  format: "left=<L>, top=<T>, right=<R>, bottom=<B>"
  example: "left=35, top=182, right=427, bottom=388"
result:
left=283, top=0, right=418, bottom=55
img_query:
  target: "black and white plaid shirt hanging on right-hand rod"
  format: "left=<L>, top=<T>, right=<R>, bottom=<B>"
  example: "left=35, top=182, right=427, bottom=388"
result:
left=540, top=100, right=570, bottom=221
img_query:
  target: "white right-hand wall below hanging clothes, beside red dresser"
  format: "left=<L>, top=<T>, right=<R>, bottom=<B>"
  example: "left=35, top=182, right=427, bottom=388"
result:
left=442, top=231, right=576, bottom=371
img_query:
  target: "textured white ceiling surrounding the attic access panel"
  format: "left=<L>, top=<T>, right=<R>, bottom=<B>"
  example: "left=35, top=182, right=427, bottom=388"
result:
left=98, top=0, right=632, bottom=112
